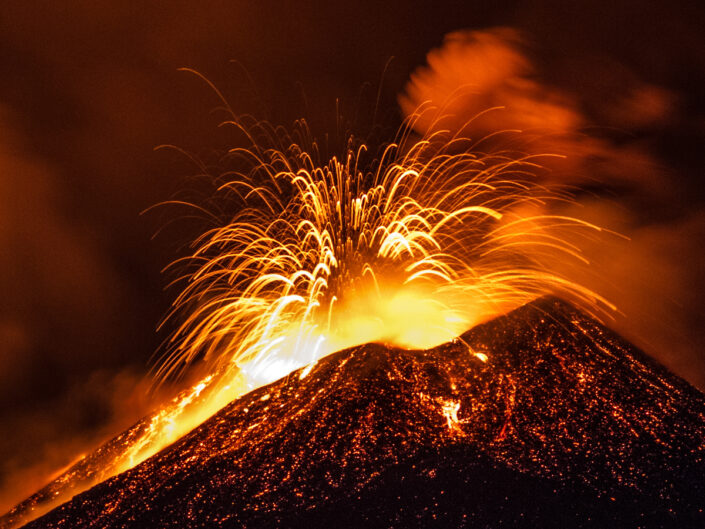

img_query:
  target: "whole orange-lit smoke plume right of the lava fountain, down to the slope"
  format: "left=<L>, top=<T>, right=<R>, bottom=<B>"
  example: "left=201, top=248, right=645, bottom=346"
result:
left=399, top=28, right=705, bottom=389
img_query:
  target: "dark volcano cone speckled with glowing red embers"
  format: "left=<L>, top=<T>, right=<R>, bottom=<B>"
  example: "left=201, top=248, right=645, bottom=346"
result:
left=17, top=298, right=705, bottom=529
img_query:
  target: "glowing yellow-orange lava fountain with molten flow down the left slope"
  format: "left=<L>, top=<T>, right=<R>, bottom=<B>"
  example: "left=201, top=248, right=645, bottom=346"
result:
left=0, top=110, right=613, bottom=519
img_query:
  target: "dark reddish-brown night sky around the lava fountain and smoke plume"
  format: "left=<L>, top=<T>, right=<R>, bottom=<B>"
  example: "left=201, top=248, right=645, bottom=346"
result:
left=0, top=0, right=705, bottom=507
